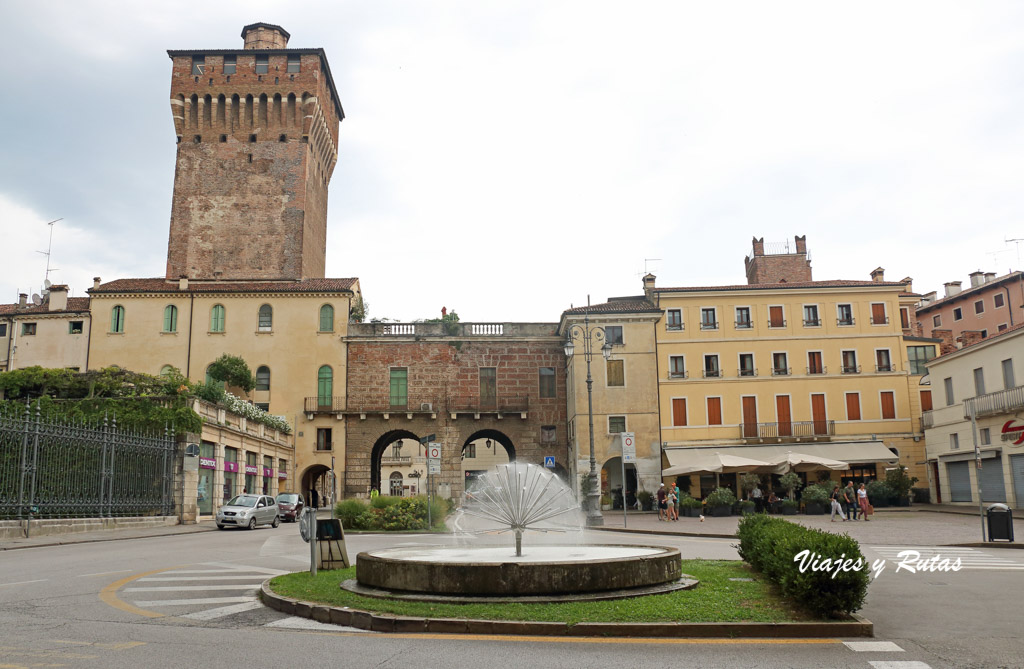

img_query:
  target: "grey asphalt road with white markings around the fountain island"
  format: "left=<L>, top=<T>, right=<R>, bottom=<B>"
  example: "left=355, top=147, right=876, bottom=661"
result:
left=0, top=526, right=1024, bottom=669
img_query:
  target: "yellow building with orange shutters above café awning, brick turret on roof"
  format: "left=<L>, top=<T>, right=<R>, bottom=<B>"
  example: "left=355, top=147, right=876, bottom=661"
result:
left=644, top=238, right=930, bottom=497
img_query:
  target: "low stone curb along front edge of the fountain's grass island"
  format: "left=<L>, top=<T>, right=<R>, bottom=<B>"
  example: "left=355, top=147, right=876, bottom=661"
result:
left=260, top=579, right=874, bottom=638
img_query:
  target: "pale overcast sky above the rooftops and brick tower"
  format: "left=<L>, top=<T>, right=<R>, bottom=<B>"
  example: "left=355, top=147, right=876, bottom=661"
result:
left=0, top=0, right=1024, bottom=322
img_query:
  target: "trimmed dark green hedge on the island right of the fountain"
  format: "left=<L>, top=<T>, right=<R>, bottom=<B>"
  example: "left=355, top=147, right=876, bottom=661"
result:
left=736, top=513, right=870, bottom=617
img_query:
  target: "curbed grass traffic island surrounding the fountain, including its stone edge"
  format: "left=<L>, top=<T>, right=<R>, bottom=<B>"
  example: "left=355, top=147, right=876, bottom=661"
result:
left=261, top=560, right=873, bottom=638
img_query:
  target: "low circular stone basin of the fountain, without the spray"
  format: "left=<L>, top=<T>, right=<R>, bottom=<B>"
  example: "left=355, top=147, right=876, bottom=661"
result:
left=355, top=545, right=681, bottom=596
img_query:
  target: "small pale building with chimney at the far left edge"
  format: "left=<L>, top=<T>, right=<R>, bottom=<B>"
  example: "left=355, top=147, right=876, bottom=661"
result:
left=0, top=285, right=90, bottom=372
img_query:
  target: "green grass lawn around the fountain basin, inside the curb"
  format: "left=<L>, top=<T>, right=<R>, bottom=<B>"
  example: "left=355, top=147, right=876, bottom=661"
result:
left=270, top=559, right=810, bottom=624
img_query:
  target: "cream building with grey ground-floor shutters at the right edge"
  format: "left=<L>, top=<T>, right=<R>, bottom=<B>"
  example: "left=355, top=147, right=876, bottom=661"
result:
left=924, top=325, right=1024, bottom=508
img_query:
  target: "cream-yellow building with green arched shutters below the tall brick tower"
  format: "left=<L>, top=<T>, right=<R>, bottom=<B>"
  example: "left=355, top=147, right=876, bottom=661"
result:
left=89, top=272, right=360, bottom=499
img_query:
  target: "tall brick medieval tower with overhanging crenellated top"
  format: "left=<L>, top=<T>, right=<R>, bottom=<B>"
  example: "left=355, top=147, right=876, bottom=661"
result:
left=167, top=24, right=345, bottom=281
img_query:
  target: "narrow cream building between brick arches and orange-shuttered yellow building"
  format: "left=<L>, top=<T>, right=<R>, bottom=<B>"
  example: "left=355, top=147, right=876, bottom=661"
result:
left=558, top=296, right=662, bottom=494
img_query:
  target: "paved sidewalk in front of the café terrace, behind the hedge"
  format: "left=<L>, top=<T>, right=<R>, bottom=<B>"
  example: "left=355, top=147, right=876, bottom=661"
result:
left=589, top=504, right=1024, bottom=548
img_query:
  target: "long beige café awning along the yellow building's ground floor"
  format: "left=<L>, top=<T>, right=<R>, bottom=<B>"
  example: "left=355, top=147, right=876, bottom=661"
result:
left=663, top=442, right=899, bottom=476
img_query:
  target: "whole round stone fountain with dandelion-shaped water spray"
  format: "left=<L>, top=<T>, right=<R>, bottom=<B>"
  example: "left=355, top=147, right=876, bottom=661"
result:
left=342, top=463, right=696, bottom=601
